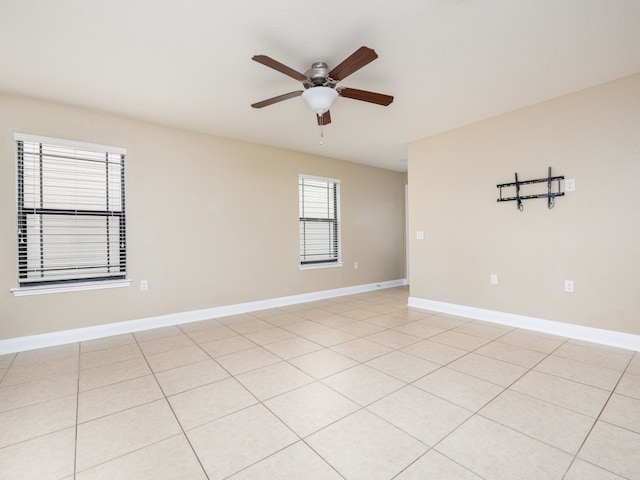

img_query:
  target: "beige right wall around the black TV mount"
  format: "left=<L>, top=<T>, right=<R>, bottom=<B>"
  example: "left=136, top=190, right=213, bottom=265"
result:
left=409, top=75, right=640, bottom=334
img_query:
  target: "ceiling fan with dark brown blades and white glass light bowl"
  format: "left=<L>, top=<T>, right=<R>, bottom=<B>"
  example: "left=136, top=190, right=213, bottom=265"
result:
left=251, top=47, right=393, bottom=126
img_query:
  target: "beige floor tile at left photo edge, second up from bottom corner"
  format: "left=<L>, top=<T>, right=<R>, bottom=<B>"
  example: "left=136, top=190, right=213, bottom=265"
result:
left=0, top=395, right=77, bottom=448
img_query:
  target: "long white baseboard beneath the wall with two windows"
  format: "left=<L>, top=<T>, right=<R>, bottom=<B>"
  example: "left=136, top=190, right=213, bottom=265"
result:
left=0, top=279, right=407, bottom=355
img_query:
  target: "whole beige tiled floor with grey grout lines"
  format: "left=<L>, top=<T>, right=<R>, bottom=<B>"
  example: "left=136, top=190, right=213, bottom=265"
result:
left=0, top=288, right=640, bottom=480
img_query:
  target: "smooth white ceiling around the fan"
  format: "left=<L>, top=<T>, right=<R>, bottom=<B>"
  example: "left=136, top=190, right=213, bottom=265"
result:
left=0, top=0, right=640, bottom=171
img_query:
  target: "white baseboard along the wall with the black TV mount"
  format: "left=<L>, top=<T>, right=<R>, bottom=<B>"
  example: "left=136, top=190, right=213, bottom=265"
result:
left=408, top=297, right=640, bottom=351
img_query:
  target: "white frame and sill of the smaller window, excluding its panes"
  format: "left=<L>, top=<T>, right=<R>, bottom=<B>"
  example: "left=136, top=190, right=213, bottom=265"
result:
left=298, top=173, right=343, bottom=270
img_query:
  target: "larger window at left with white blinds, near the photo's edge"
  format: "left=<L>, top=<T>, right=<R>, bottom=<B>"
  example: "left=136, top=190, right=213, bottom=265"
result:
left=15, top=134, right=127, bottom=287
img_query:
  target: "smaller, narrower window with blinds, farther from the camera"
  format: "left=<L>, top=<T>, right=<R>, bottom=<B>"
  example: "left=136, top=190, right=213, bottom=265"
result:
left=299, top=175, right=341, bottom=266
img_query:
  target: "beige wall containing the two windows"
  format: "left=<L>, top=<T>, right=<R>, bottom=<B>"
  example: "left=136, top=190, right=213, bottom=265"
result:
left=0, top=95, right=406, bottom=339
